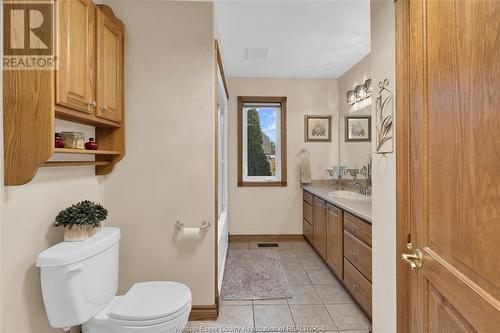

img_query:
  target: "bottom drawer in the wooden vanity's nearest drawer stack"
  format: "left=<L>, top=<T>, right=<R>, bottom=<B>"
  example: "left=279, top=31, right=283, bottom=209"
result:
left=344, top=259, right=372, bottom=317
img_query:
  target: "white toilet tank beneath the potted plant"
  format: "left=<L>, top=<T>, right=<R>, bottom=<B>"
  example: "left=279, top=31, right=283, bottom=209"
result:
left=36, top=228, right=120, bottom=328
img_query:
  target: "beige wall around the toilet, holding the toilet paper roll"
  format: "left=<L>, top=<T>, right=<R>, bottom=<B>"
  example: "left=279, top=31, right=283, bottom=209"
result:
left=0, top=1, right=215, bottom=333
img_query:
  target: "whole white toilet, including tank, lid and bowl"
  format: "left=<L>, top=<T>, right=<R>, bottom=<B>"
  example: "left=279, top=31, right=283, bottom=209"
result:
left=36, top=228, right=191, bottom=333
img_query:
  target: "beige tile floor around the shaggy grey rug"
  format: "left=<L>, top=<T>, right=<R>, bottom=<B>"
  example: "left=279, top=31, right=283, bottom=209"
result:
left=184, top=242, right=370, bottom=333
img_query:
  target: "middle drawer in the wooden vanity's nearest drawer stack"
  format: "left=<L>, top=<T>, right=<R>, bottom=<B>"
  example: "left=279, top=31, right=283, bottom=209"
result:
left=344, top=230, right=372, bottom=281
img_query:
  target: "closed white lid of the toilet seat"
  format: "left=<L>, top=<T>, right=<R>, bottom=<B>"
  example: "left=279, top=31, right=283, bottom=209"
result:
left=109, top=281, right=191, bottom=320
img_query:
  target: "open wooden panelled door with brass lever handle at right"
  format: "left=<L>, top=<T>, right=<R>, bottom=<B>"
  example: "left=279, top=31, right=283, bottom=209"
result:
left=398, top=0, right=500, bottom=333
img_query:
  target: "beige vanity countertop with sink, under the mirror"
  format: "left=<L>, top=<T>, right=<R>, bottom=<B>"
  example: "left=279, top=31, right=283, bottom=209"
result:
left=301, top=185, right=372, bottom=223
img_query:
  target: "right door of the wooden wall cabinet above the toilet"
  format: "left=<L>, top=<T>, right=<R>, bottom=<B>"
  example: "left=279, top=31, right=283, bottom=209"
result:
left=96, top=6, right=124, bottom=122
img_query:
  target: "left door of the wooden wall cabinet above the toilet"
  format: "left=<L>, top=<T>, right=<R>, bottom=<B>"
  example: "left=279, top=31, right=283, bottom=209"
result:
left=56, top=0, right=95, bottom=114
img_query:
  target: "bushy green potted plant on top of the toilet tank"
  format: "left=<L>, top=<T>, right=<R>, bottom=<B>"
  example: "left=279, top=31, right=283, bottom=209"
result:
left=54, top=200, right=108, bottom=242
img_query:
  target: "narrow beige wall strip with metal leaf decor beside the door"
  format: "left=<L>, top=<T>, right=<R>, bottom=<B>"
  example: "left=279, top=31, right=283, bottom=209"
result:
left=371, top=0, right=397, bottom=333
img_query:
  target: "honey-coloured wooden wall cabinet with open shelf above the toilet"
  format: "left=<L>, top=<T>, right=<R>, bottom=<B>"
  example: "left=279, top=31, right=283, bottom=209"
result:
left=3, top=0, right=125, bottom=186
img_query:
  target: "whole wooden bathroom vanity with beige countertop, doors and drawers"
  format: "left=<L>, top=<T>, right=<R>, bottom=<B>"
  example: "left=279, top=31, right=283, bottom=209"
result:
left=302, top=185, right=372, bottom=317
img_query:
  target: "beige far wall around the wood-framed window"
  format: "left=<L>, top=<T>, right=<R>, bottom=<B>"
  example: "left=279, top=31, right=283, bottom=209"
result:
left=228, top=78, right=338, bottom=234
